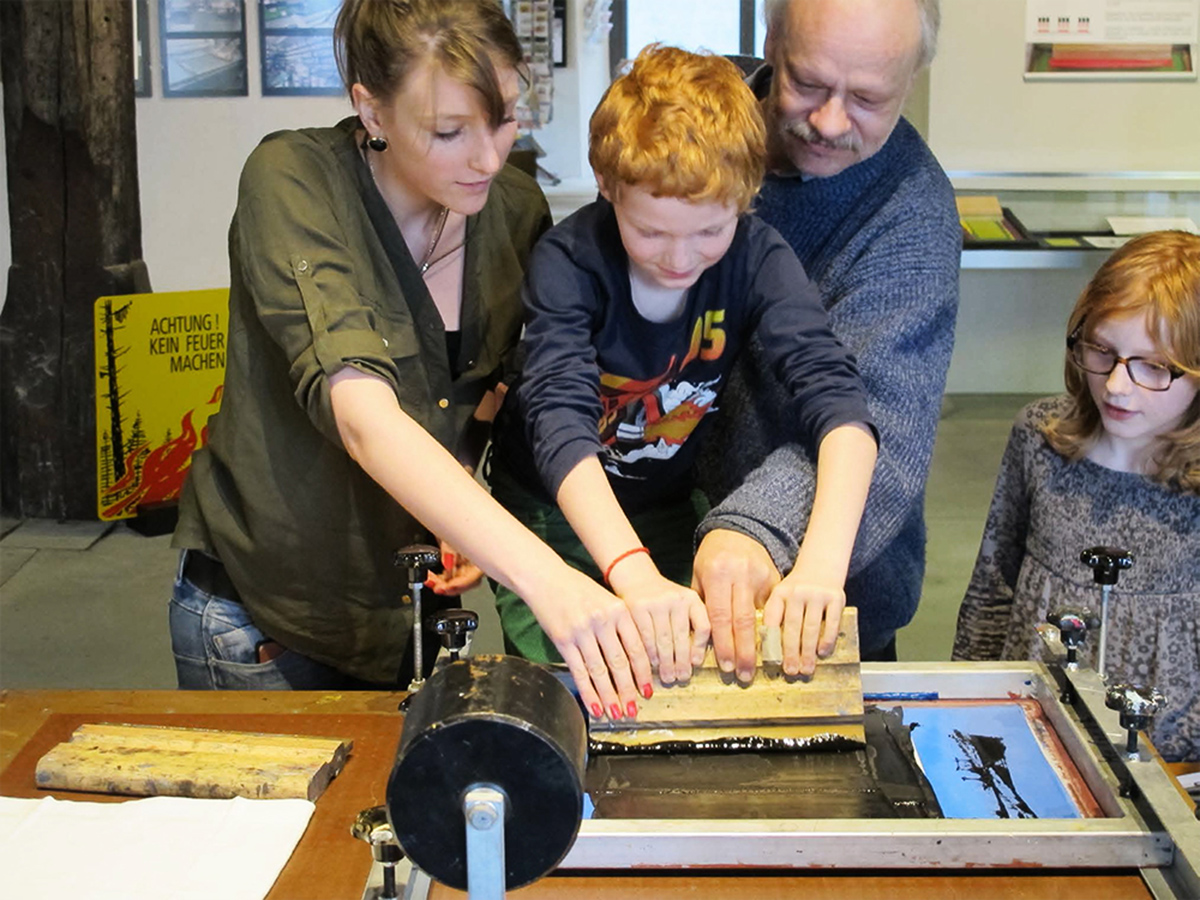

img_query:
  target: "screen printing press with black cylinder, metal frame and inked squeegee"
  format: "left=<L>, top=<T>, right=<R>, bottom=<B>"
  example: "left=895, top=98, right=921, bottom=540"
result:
left=355, top=548, right=1200, bottom=900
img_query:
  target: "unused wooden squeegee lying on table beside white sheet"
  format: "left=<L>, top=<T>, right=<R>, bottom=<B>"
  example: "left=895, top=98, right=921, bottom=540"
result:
left=35, top=724, right=353, bottom=800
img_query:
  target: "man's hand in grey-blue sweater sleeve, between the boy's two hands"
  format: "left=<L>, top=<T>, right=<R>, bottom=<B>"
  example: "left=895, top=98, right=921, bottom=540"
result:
left=691, top=528, right=780, bottom=682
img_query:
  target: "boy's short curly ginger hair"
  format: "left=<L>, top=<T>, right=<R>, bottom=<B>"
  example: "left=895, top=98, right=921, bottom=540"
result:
left=588, top=43, right=767, bottom=212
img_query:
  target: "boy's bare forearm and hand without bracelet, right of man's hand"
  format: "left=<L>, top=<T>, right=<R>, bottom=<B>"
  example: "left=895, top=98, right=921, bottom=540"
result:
left=763, top=422, right=876, bottom=674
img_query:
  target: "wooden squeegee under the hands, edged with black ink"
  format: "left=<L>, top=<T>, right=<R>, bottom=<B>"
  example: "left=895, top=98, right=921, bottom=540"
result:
left=590, top=607, right=864, bottom=746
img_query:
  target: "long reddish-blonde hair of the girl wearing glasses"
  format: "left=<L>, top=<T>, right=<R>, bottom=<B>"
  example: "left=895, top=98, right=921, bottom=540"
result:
left=1046, top=226, right=1200, bottom=493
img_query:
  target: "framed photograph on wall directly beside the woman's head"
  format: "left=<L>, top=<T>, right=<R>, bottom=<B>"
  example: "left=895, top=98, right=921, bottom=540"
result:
left=258, top=0, right=342, bottom=96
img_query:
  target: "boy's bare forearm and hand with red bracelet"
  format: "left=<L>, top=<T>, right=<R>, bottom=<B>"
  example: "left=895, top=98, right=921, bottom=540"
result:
left=556, top=456, right=708, bottom=681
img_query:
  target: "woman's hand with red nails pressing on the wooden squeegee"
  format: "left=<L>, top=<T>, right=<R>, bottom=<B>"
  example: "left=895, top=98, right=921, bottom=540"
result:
left=526, top=563, right=650, bottom=719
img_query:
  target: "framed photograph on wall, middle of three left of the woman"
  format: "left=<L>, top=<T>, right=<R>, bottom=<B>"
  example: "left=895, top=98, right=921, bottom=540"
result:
left=158, top=0, right=247, bottom=97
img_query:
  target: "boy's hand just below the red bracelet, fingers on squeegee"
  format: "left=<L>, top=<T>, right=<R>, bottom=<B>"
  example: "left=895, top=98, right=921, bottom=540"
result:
left=611, top=553, right=709, bottom=694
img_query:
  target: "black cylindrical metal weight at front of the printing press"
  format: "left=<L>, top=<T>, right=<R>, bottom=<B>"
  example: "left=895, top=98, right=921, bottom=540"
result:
left=388, top=656, right=587, bottom=890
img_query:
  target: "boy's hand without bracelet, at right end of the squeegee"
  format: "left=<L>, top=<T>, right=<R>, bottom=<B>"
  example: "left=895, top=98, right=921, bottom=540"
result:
left=762, top=561, right=846, bottom=676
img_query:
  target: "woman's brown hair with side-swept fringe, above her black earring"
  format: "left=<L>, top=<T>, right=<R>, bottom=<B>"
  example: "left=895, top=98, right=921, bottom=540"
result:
left=334, top=0, right=523, bottom=127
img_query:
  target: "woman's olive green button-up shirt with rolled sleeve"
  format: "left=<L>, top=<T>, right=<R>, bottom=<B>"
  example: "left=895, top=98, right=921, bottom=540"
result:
left=174, top=119, right=550, bottom=683
